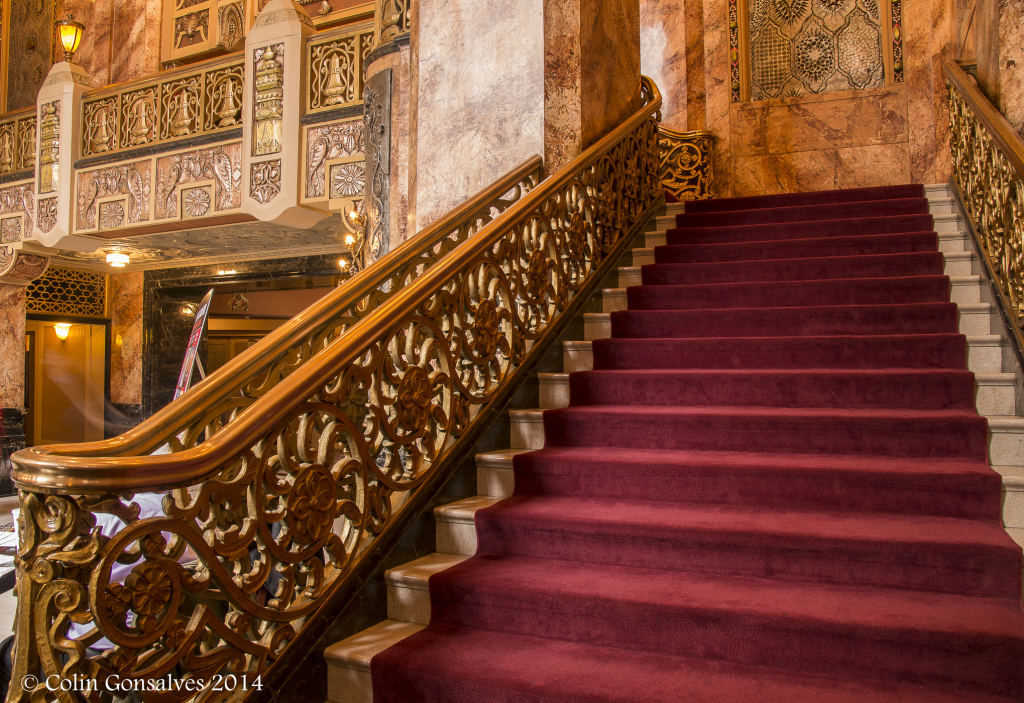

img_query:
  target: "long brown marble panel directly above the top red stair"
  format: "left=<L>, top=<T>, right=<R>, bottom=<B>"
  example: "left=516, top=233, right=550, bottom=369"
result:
left=733, top=143, right=910, bottom=196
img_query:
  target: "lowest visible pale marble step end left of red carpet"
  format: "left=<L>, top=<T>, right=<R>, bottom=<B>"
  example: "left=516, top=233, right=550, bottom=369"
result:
left=324, top=620, right=424, bottom=703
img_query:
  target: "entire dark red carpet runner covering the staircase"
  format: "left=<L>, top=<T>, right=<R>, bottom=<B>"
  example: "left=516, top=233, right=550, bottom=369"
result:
left=372, top=185, right=1024, bottom=703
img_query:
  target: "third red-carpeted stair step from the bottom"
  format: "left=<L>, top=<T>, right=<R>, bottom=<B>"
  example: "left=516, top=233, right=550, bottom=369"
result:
left=475, top=495, right=1022, bottom=603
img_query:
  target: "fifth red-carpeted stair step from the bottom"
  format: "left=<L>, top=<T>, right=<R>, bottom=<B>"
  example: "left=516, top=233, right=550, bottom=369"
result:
left=540, top=405, right=987, bottom=464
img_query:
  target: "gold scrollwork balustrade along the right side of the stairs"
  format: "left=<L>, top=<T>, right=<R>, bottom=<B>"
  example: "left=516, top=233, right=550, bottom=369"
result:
left=945, top=61, right=1024, bottom=339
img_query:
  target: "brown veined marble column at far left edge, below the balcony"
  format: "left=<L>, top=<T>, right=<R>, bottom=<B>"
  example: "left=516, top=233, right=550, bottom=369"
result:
left=0, top=284, right=25, bottom=495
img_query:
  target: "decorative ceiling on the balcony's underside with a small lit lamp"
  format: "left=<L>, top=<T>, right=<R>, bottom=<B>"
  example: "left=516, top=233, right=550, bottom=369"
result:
left=50, top=215, right=356, bottom=273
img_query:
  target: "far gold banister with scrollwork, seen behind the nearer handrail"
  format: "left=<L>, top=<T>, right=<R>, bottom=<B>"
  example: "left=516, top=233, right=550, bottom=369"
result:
left=14, top=157, right=542, bottom=472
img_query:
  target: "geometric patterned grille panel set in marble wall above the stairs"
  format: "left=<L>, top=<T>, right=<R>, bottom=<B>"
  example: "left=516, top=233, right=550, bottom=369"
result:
left=750, top=0, right=885, bottom=100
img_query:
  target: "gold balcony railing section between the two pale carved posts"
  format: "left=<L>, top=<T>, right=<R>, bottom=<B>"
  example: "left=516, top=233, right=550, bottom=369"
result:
left=82, top=53, right=244, bottom=157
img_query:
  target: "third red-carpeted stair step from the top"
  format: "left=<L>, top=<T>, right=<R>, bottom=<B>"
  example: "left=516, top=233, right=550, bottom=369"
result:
left=662, top=215, right=935, bottom=245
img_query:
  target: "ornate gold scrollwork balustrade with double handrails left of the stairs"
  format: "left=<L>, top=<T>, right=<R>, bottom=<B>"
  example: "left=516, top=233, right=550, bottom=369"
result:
left=8, top=80, right=662, bottom=703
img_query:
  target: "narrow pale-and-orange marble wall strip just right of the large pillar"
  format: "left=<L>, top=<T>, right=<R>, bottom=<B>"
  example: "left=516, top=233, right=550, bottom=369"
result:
left=638, top=0, right=688, bottom=131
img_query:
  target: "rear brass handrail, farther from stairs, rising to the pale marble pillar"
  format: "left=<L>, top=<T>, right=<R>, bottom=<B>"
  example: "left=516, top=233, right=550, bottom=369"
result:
left=15, top=156, right=543, bottom=480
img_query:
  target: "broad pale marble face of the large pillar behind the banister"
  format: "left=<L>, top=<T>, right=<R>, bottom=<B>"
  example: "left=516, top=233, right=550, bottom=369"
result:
left=416, top=0, right=544, bottom=230
